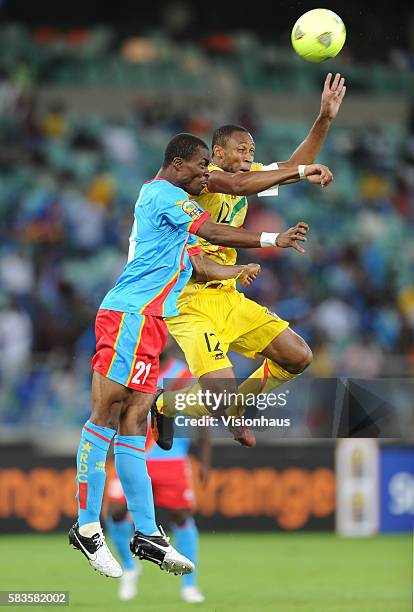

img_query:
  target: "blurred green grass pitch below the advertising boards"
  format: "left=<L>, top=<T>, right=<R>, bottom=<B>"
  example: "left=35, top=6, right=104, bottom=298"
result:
left=0, top=533, right=413, bottom=612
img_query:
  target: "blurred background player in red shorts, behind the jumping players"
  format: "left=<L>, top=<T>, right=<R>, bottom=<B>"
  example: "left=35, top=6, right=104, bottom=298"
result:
left=105, top=352, right=210, bottom=603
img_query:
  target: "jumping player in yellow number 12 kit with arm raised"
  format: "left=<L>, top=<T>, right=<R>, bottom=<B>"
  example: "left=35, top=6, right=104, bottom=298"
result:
left=154, top=74, right=346, bottom=446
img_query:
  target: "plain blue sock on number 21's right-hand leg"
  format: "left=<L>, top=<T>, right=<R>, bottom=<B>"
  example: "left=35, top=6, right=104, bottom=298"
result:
left=114, top=435, right=158, bottom=535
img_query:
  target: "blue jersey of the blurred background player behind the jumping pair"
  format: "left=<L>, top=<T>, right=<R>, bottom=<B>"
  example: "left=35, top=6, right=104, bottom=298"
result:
left=146, top=359, right=191, bottom=461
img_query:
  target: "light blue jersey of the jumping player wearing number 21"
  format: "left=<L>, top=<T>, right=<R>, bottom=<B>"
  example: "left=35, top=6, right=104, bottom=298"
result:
left=101, top=179, right=210, bottom=317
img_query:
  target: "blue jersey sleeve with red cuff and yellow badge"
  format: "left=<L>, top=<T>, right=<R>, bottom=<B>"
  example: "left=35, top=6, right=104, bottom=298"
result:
left=160, top=188, right=210, bottom=234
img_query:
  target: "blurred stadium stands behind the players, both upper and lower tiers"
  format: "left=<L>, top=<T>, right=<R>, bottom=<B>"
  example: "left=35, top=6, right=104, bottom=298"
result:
left=0, top=26, right=414, bottom=426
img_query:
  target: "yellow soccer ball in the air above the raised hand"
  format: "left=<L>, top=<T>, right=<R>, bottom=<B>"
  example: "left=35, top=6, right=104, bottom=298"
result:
left=291, top=9, right=346, bottom=62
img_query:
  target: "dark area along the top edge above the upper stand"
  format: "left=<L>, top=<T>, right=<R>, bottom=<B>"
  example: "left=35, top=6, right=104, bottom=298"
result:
left=1, top=0, right=412, bottom=58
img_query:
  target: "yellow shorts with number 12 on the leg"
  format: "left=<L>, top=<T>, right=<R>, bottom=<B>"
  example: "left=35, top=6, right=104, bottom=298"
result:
left=166, top=287, right=289, bottom=378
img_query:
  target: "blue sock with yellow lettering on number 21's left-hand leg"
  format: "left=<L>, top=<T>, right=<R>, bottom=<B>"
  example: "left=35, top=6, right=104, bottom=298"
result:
left=76, top=421, right=115, bottom=527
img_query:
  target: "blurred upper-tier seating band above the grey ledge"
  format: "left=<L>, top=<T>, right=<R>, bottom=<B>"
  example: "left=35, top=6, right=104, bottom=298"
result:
left=0, top=24, right=412, bottom=95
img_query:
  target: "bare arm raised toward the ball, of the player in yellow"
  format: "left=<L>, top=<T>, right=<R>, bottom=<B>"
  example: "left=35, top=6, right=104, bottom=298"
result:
left=278, top=73, right=346, bottom=169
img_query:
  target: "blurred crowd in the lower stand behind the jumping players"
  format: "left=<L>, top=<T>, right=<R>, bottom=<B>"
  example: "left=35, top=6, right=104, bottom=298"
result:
left=0, top=63, right=414, bottom=424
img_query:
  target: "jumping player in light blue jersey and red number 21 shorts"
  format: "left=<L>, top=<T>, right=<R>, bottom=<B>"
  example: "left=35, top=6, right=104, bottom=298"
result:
left=69, top=134, right=307, bottom=577
